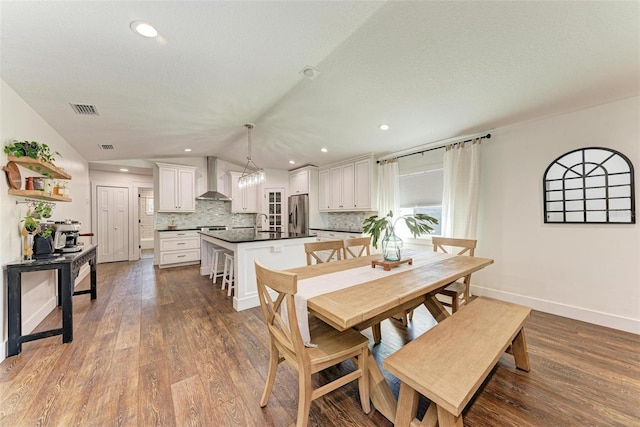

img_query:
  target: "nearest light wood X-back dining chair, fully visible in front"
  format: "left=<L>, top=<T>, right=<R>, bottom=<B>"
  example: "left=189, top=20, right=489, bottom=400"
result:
left=255, top=260, right=371, bottom=427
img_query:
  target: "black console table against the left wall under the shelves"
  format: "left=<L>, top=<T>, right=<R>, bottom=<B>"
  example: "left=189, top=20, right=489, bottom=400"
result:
left=7, top=245, right=96, bottom=356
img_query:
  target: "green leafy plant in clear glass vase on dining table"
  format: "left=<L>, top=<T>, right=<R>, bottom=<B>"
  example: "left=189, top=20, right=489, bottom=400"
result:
left=362, top=211, right=438, bottom=261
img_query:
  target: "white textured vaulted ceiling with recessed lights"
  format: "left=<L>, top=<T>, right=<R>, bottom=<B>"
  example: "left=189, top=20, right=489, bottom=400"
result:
left=0, top=1, right=640, bottom=174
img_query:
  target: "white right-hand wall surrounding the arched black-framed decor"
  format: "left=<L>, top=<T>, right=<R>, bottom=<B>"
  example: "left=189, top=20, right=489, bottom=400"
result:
left=472, top=97, right=640, bottom=333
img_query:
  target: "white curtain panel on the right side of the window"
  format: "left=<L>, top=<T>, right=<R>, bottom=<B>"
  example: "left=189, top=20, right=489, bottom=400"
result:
left=442, top=138, right=480, bottom=239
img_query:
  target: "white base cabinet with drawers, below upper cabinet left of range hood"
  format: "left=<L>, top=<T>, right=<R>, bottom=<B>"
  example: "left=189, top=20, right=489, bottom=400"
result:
left=158, top=231, right=200, bottom=268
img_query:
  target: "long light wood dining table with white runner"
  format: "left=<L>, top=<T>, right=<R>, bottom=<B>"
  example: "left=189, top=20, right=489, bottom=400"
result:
left=286, top=250, right=493, bottom=422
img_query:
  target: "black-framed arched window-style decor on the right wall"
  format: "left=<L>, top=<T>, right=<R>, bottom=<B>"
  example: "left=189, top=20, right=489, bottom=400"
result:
left=543, top=147, right=636, bottom=224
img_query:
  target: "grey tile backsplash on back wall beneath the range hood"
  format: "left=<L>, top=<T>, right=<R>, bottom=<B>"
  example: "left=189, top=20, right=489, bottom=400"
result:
left=156, top=200, right=256, bottom=230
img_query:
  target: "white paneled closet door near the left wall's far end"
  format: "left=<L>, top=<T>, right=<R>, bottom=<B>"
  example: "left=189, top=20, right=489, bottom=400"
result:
left=96, top=186, right=129, bottom=263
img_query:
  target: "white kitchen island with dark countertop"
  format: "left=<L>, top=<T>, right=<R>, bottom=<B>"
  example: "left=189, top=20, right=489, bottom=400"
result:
left=200, top=228, right=316, bottom=311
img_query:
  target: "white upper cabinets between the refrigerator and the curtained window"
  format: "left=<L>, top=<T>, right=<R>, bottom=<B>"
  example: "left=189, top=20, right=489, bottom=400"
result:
left=319, top=156, right=377, bottom=212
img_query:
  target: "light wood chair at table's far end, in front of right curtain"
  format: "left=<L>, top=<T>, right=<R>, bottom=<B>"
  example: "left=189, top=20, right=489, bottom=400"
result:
left=431, top=237, right=478, bottom=313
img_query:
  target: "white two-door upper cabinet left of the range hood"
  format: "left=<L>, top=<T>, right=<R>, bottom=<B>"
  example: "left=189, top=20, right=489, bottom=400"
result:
left=156, top=163, right=197, bottom=212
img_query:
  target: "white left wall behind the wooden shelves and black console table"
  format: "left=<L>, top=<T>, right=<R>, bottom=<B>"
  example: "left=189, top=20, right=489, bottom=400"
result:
left=0, top=80, right=91, bottom=361
